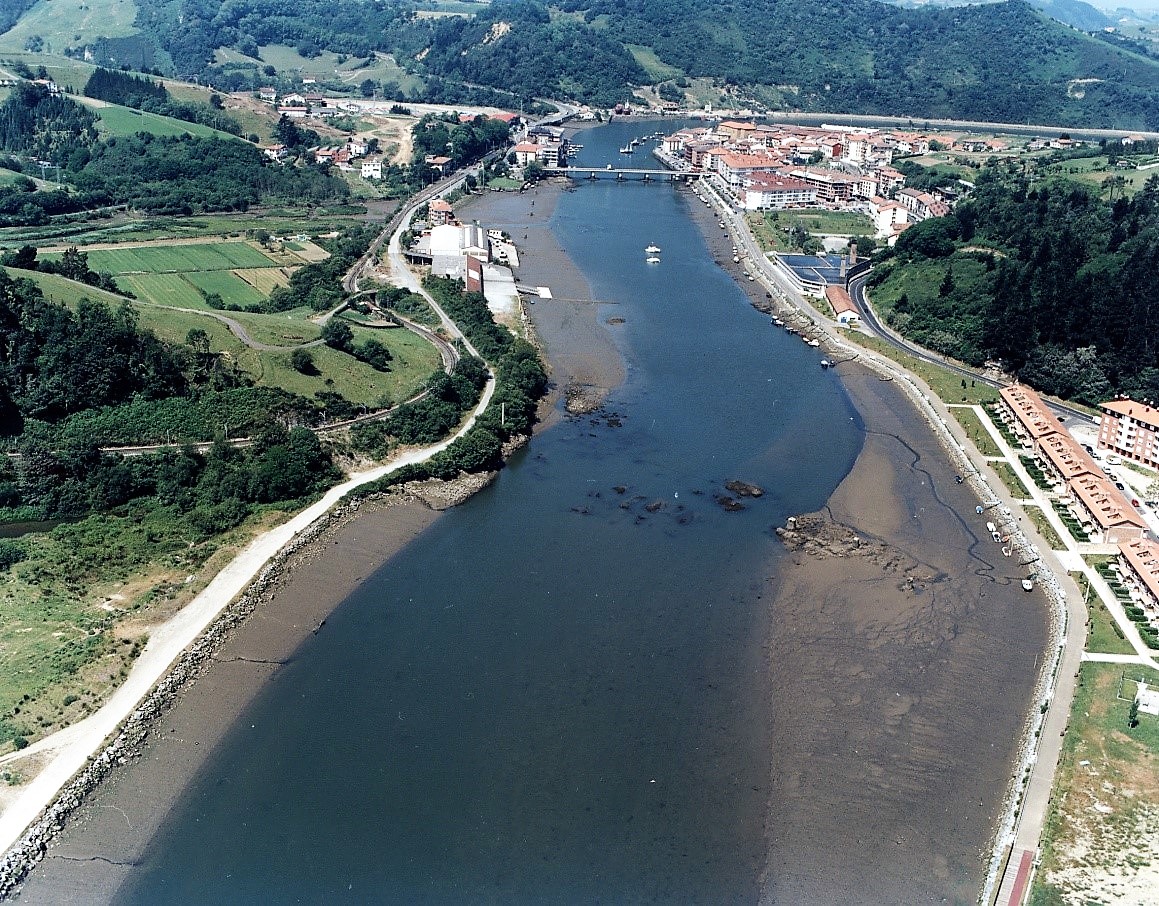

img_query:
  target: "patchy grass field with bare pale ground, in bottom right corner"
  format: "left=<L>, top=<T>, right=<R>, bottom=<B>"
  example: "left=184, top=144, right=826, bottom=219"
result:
left=1030, top=663, right=1159, bottom=906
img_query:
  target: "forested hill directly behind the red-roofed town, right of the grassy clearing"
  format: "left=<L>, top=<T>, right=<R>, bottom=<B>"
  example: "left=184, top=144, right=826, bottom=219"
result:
left=544, top=0, right=1159, bottom=129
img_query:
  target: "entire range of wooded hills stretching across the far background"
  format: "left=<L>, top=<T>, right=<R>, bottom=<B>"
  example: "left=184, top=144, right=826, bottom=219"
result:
left=58, top=0, right=1159, bottom=130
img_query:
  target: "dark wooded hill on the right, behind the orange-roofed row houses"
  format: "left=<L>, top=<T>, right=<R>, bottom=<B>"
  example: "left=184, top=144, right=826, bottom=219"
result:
left=870, top=172, right=1159, bottom=405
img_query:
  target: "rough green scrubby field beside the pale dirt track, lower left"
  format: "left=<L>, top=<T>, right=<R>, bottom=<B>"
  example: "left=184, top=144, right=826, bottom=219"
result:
left=0, top=507, right=294, bottom=747
